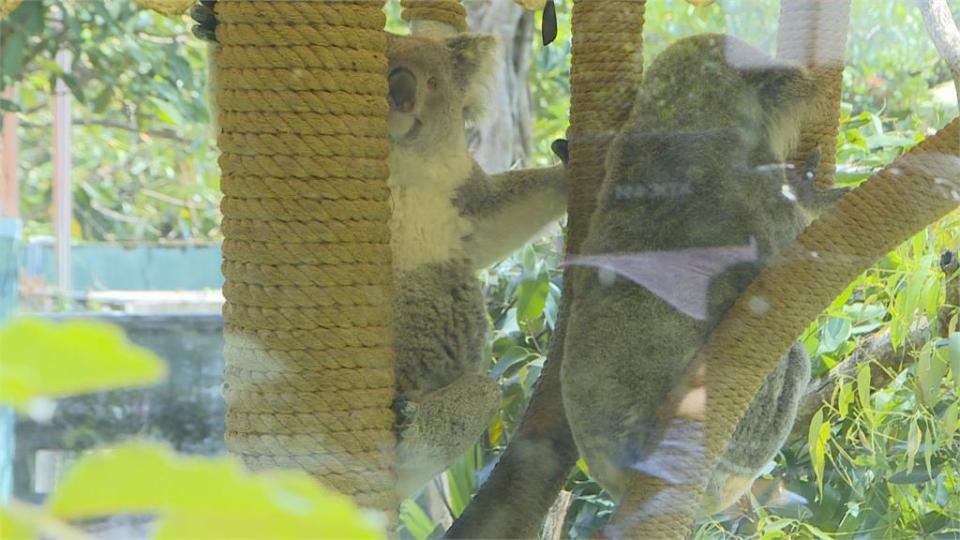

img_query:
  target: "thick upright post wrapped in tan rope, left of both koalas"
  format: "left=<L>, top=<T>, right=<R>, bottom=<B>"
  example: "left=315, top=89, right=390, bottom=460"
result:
left=215, top=0, right=396, bottom=516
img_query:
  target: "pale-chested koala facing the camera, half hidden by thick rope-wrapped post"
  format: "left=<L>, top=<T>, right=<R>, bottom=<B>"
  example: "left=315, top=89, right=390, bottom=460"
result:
left=192, top=0, right=566, bottom=497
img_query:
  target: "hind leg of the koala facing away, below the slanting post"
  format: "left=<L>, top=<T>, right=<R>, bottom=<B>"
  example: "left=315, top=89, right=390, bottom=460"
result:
left=701, top=343, right=810, bottom=515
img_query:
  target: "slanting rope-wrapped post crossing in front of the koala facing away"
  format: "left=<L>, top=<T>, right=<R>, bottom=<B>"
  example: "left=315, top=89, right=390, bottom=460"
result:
left=625, top=119, right=960, bottom=538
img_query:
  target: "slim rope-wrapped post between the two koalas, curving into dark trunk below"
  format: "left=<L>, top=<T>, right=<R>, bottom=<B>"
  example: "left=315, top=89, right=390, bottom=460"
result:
left=446, top=0, right=645, bottom=538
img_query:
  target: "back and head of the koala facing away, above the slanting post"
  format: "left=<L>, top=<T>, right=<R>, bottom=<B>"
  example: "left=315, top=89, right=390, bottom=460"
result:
left=562, top=35, right=816, bottom=496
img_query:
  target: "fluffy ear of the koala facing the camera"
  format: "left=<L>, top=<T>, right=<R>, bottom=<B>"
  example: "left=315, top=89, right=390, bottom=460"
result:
left=446, top=34, right=499, bottom=121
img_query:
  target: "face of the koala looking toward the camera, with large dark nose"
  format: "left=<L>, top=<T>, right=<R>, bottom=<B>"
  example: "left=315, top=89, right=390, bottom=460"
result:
left=387, top=35, right=495, bottom=152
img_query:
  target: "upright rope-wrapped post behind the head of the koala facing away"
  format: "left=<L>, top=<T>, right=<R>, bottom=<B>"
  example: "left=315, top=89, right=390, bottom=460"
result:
left=777, top=0, right=850, bottom=188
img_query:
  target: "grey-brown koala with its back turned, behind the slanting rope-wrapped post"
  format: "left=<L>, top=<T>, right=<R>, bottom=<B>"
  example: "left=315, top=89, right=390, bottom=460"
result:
left=561, top=34, right=837, bottom=514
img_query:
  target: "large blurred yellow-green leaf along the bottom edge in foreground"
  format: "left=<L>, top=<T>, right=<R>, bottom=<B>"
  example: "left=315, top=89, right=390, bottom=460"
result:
left=47, top=442, right=383, bottom=538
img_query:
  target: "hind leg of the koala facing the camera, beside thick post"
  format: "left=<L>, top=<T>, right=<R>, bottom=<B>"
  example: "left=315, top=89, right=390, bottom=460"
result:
left=397, top=372, right=500, bottom=497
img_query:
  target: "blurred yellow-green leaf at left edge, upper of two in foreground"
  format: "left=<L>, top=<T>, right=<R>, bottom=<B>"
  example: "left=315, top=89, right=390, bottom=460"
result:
left=0, top=319, right=167, bottom=412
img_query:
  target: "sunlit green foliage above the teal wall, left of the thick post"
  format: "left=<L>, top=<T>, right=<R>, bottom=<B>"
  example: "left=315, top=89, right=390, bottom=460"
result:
left=0, top=0, right=220, bottom=241
